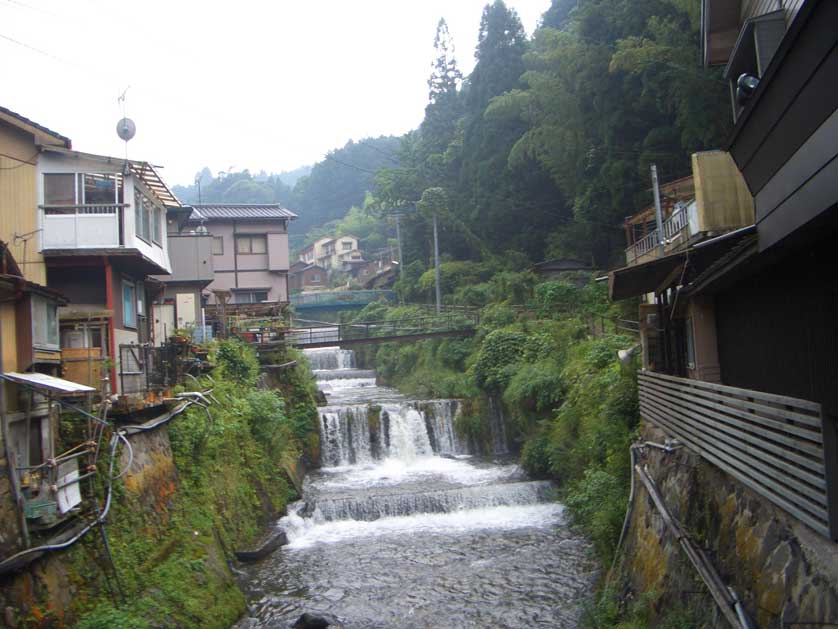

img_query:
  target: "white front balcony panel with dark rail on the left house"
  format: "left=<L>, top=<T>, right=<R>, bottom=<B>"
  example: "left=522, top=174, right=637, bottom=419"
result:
left=41, top=203, right=125, bottom=249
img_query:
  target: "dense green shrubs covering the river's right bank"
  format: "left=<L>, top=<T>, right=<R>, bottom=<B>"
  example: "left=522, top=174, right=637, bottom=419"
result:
left=356, top=272, right=638, bottom=565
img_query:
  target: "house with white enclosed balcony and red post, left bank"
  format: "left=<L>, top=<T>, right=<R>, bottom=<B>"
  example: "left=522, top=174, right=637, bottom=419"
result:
left=34, top=146, right=180, bottom=394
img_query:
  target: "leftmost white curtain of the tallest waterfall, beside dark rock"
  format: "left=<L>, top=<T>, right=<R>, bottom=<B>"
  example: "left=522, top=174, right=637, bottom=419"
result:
left=320, top=405, right=372, bottom=467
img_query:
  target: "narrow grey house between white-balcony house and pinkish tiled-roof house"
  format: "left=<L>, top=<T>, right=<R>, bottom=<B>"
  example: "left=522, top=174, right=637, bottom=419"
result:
left=151, top=207, right=215, bottom=346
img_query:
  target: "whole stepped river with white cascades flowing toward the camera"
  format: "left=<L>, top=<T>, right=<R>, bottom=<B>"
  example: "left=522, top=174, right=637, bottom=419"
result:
left=240, top=348, right=596, bottom=629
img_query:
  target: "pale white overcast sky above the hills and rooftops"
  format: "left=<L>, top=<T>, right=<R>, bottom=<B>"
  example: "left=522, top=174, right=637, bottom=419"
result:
left=0, top=0, right=550, bottom=185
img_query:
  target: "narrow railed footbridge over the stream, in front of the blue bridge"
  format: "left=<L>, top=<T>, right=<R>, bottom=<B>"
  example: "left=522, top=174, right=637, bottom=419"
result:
left=280, top=313, right=480, bottom=348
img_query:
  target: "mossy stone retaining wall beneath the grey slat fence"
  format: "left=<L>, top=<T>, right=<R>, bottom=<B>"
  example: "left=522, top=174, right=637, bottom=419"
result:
left=622, top=424, right=838, bottom=629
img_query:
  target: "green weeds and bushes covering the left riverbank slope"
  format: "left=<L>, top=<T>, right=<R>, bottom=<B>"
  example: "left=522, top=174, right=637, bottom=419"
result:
left=61, top=341, right=318, bottom=629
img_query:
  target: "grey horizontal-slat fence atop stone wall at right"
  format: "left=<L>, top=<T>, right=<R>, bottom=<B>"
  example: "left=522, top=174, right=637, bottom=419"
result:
left=638, top=371, right=836, bottom=537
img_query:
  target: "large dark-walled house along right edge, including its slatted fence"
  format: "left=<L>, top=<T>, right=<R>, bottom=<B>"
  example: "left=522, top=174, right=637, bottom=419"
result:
left=609, top=0, right=838, bottom=552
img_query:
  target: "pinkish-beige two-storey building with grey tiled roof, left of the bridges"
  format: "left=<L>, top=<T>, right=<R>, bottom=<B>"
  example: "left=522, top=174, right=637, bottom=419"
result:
left=188, top=204, right=297, bottom=304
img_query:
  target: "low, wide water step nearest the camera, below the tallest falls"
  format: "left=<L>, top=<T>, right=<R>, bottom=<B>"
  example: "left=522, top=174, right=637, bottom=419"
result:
left=305, top=481, right=555, bottom=522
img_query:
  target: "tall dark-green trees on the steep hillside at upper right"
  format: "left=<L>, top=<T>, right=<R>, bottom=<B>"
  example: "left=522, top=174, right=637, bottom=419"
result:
left=376, top=0, right=729, bottom=267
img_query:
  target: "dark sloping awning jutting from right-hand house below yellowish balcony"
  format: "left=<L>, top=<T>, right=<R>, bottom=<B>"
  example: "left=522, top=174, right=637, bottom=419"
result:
left=608, top=225, right=756, bottom=301
